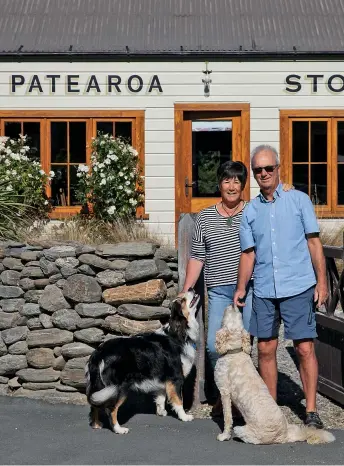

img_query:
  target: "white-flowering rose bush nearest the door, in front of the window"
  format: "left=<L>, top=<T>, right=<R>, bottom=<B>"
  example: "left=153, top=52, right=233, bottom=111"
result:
left=76, top=133, right=144, bottom=222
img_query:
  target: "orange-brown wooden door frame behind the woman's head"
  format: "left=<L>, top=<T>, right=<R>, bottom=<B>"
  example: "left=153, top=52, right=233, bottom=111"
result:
left=174, top=103, right=250, bottom=241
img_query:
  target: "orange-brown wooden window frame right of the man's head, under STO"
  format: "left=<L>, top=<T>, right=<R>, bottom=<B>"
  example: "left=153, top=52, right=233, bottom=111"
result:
left=280, top=109, right=344, bottom=218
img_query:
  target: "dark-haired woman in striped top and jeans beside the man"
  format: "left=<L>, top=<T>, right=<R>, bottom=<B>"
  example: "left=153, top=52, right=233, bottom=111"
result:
left=182, top=162, right=290, bottom=414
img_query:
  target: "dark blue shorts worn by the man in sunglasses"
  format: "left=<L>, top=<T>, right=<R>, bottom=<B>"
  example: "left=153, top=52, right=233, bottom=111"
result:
left=250, top=286, right=317, bottom=340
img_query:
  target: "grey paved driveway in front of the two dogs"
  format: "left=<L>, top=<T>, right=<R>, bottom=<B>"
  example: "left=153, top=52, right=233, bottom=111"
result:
left=0, top=397, right=344, bottom=465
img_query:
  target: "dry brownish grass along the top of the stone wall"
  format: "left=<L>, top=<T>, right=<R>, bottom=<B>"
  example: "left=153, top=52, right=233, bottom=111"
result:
left=18, top=217, right=163, bottom=246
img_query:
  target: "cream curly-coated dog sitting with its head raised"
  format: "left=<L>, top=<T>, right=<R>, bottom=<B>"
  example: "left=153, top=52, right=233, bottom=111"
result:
left=215, top=306, right=335, bottom=444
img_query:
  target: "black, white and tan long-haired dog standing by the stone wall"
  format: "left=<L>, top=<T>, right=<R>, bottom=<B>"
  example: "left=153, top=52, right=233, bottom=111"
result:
left=85, top=289, right=199, bottom=434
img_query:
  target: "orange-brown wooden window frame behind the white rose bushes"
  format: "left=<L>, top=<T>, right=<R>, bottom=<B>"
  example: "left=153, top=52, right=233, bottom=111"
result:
left=0, top=109, right=149, bottom=220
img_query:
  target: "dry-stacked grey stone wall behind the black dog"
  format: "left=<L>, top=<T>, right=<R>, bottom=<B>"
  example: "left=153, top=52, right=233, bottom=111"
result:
left=0, top=241, right=178, bottom=403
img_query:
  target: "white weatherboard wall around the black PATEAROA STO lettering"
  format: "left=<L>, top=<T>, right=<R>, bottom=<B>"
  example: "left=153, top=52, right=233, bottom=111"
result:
left=0, top=61, right=344, bottom=242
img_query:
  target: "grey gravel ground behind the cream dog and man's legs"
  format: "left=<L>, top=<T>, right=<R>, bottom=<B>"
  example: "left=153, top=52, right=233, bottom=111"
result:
left=192, top=329, right=344, bottom=429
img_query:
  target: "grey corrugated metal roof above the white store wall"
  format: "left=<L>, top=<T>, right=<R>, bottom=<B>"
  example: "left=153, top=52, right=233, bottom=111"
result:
left=0, top=0, right=344, bottom=56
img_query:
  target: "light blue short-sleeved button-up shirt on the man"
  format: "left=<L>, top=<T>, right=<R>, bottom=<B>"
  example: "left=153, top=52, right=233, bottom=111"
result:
left=240, top=184, right=319, bottom=298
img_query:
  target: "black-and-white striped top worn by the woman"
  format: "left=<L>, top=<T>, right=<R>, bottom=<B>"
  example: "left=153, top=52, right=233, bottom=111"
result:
left=190, top=203, right=247, bottom=287
